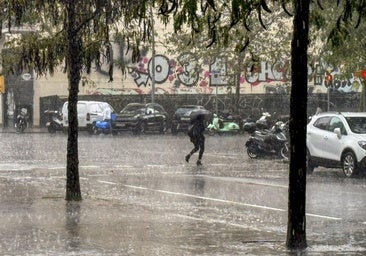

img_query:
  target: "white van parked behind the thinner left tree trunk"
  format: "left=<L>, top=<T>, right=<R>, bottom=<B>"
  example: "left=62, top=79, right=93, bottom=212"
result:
left=62, top=101, right=113, bottom=133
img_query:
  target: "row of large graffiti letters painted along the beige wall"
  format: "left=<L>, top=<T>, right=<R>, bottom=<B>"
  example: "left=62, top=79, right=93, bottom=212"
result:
left=130, top=52, right=361, bottom=92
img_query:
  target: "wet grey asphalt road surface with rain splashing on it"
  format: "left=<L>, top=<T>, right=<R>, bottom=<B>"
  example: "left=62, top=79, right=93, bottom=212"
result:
left=0, top=133, right=366, bottom=255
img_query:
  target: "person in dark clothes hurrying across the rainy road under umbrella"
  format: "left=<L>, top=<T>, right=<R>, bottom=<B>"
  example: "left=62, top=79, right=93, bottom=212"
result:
left=185, top=114, right=205, bottom=165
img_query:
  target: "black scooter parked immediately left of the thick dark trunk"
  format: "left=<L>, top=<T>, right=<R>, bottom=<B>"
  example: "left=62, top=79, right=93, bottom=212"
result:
left=245, top=122, right=289, bottom=160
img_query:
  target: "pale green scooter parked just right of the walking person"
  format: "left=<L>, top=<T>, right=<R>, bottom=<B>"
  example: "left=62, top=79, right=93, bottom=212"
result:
left=207, top=114, right=242, bottom=135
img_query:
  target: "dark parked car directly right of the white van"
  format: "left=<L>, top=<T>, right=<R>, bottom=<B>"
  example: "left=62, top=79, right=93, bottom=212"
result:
left=112, top=103, right=168, bottom=134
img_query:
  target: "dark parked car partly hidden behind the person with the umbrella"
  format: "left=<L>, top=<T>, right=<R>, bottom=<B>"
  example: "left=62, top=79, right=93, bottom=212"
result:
left=171, top=105, right=210, bottom=134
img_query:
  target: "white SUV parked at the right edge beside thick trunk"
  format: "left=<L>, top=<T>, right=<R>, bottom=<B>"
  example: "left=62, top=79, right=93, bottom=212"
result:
left=306, top=112, right=366, bottom=177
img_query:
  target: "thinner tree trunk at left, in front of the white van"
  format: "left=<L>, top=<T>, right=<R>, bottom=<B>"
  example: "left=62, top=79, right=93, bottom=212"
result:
left=66, top=1, right=82, bottom=201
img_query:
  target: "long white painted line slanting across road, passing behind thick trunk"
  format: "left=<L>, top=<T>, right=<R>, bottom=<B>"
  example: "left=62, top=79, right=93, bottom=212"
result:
left=122, top=184, right=342, bottom=220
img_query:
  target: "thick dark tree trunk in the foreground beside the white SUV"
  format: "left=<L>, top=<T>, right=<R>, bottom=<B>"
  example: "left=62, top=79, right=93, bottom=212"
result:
left=286, top=0, right=310, bottom=249
